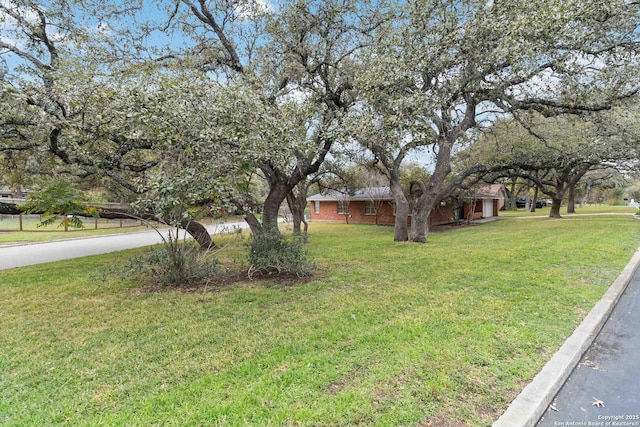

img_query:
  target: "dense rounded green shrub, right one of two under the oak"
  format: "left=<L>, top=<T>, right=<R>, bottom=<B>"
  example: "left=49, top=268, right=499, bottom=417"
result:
left=249, top=230, right=315, bottom=278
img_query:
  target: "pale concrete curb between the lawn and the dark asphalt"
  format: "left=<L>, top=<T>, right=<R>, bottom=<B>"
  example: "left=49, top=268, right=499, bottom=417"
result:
left=493, top=249, right=640, bottom=427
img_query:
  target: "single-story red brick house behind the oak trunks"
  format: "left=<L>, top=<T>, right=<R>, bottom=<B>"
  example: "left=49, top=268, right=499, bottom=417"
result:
left=307, top=184, right=504, bottom=229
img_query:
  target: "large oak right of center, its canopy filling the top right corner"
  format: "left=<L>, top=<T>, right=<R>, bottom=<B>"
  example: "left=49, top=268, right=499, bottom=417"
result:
left=350, top=0, right=639, bottom=242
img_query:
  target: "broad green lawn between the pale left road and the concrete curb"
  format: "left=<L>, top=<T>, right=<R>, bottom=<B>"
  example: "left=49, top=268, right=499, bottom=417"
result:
left=0, top=216, right=640, bottom=426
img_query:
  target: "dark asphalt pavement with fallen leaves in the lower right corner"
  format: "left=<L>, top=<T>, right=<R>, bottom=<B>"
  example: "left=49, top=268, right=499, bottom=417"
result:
left=537, top=268, right=640, bottom=427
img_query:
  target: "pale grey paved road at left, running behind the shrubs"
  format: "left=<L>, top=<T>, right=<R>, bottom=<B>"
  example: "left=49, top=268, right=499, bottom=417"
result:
left=0, top=222, right=247, bottom=270
